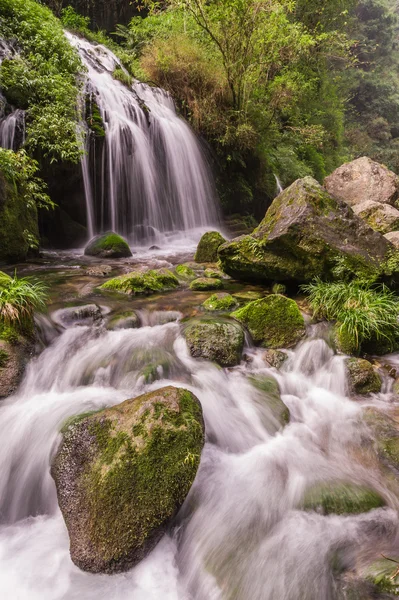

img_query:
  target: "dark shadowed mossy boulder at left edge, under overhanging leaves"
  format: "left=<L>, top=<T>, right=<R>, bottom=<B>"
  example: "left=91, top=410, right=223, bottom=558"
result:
left=0, top=171, right=39, bottom=262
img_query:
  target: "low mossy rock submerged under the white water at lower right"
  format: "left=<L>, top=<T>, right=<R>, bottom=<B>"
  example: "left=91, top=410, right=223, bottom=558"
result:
left=302, top=482, right=385, bottom=515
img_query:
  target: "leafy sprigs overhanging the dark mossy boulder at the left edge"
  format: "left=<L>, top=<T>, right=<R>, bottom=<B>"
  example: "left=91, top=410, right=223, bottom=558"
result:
left=0, top=148, right=55, bottom=210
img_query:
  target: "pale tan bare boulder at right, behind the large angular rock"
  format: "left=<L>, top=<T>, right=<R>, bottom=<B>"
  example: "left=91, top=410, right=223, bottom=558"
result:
left=324, top=156, right=399, bottom=206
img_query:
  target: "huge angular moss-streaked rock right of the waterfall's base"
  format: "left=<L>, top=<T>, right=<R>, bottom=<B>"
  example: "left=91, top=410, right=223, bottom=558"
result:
left=218, top=177, right=394, bottom=283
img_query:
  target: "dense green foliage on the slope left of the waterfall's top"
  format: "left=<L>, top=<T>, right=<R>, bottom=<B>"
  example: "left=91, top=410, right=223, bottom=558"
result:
left=0, top=0, right=81, bottom=162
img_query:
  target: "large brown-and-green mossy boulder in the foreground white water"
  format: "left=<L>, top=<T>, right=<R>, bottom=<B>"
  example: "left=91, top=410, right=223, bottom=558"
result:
left=51, top=387, right=204, bottom=573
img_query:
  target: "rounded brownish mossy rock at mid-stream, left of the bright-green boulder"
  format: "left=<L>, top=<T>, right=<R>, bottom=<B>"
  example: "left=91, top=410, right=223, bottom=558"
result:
left=183, top=319, right=244, bottom=367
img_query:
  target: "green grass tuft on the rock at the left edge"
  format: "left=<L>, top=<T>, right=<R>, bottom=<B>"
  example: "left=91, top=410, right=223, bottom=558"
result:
left=0, top=271, right=47, bottom=330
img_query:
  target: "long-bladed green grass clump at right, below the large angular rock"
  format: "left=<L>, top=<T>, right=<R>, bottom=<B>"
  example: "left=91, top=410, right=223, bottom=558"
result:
left=302, top=279, right=399, bottom=351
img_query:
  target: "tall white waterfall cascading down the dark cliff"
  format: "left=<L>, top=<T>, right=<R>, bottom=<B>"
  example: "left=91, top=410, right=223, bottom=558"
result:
left=66, top=33, right=218, bottom=243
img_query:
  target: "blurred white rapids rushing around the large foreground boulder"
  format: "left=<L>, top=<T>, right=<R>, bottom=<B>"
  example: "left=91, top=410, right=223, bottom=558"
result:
left=0, top=304, right=398, bottom=600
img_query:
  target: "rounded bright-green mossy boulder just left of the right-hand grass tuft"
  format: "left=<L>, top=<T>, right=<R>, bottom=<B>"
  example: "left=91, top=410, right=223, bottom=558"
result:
left=232, top=294, right=305, bottom=348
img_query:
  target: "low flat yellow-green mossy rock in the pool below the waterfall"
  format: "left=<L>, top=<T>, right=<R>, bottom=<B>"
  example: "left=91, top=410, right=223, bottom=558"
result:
left=100, top=269, right=179, bottom=295
